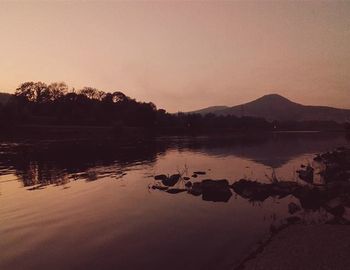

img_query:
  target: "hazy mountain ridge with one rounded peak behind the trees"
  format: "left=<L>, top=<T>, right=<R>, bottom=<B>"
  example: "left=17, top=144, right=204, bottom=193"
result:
left=191, top=94, right=350, bottom=123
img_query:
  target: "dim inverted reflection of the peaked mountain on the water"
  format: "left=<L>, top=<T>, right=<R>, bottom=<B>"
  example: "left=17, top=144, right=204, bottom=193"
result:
left=176, top=133, right=349, bottom=168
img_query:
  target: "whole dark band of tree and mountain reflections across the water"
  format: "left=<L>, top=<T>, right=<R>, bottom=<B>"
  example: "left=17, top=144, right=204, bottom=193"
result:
left=0, top=133, right=347, bottom=190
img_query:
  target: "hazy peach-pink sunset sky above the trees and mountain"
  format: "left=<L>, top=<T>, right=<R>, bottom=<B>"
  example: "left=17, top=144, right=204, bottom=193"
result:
left=0, top=1, right=350, bottom=112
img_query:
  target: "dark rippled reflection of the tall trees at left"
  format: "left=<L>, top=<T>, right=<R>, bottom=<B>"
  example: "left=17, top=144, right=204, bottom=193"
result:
left=0, top=139, right=164, bottom=189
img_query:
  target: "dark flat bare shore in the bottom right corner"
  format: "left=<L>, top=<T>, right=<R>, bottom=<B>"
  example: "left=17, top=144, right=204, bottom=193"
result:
left=241, top=225, right=350, bottom=270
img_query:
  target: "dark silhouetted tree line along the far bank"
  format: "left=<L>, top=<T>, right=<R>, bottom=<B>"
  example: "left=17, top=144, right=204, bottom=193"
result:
left=0, top=82, right=344, bottom=131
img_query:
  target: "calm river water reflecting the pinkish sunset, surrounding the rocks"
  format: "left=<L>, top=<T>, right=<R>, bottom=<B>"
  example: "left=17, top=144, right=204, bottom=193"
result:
left=0, top=133, right=349, bottom=270
